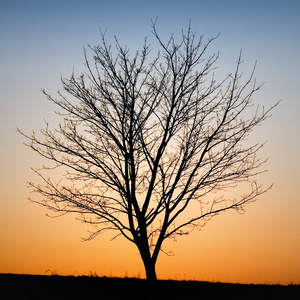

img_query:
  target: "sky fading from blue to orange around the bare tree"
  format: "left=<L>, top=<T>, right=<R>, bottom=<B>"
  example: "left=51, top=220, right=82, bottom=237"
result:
left=0, top=0, right=300, bottom=284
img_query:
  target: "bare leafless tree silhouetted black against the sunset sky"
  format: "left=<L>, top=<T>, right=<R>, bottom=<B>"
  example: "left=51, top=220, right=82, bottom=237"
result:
left=21, top=23, right=276, bottom=280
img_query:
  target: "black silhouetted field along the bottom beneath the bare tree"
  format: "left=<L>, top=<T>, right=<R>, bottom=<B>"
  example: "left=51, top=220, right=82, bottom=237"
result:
left=0, top=274, right=300, bottom=300
